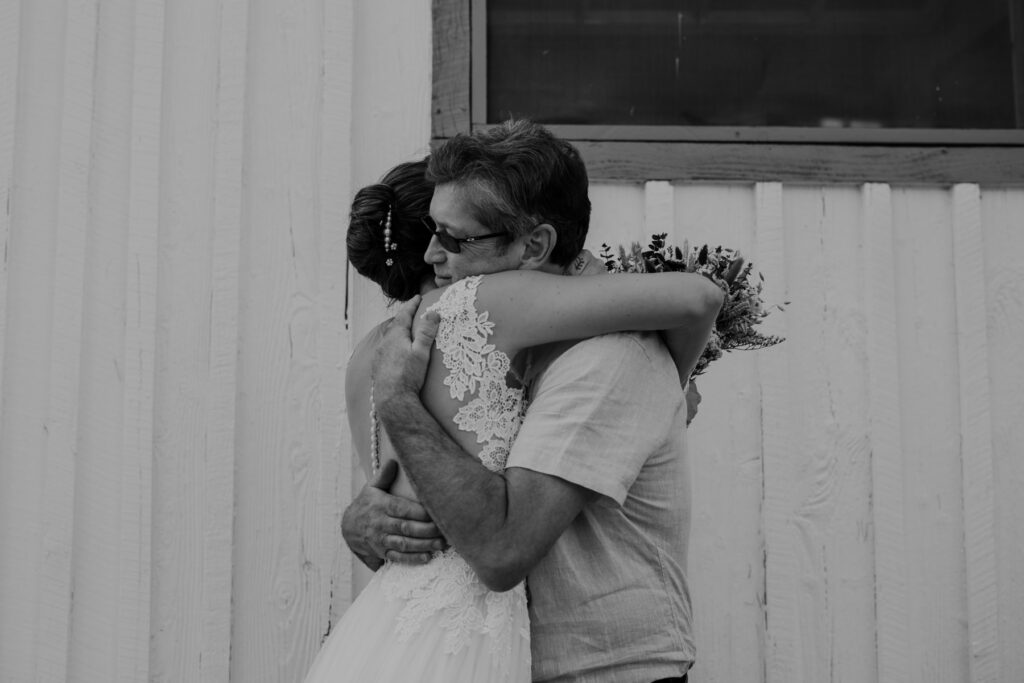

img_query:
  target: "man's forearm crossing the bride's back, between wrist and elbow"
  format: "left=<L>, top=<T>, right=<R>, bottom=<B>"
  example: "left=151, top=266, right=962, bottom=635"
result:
left=377, top=393, right=508, bottom=565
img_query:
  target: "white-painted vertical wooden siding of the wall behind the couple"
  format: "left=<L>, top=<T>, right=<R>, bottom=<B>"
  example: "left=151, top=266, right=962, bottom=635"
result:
left=0, top=0, right=1024, bottom=683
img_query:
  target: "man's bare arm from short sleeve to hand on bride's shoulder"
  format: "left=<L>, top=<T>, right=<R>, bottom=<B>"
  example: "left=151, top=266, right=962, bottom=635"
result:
left=374, top=300, right=595, bottom=591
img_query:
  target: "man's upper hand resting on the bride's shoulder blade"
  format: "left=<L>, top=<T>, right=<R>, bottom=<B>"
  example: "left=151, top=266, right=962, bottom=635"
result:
left=372, top=296, right=440, bottom=404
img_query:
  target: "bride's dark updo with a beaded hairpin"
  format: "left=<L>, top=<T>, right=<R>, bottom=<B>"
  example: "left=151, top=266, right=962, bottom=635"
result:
left=345, top=159, right=434, bottom=301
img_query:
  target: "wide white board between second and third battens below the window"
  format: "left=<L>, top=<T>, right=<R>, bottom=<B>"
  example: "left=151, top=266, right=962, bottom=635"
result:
left=759, top=186, right=874, bottom=681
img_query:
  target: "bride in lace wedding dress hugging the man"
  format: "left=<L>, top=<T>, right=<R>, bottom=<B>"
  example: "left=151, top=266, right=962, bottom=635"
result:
left=305, top=156, right=721, bottom=683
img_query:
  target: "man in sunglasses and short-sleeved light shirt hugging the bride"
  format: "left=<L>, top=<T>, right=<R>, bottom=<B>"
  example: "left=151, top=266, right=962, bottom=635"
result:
left=343, top=122, right=722, bottom=683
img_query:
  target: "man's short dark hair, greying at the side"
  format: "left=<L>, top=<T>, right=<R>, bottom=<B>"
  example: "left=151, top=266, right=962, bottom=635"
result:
left=427, top=120, right=590, bottom=265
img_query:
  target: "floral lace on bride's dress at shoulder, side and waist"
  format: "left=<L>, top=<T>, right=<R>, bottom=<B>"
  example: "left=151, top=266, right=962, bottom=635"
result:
left=381, top=275, right=526, bottom=667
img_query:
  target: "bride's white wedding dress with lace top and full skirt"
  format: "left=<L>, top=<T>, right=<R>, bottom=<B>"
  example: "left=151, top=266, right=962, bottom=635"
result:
left=305, top=275, right=530, bottom=683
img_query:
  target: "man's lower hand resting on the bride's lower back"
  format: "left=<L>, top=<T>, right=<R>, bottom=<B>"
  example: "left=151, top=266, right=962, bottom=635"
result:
left=341, top=460, right=447, bottom=570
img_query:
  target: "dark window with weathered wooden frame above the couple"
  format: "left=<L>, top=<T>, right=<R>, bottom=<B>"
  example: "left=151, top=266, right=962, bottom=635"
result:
left=434, top=0, right=1024, bottom=184
